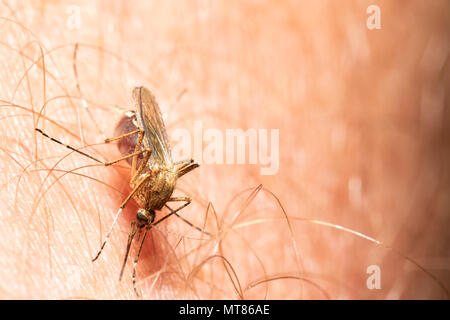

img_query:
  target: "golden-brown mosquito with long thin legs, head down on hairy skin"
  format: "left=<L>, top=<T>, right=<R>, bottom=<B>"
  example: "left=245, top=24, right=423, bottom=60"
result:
left=36, top=87, right=203, bottom=296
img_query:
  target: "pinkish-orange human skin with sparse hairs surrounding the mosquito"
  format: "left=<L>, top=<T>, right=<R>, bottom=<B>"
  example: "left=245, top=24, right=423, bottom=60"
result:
left=0, top=1, right=450, bottom=299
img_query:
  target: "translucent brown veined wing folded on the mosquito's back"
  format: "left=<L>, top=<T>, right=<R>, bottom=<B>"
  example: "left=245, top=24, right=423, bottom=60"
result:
left=133, top=87, right=172, bottom=163
